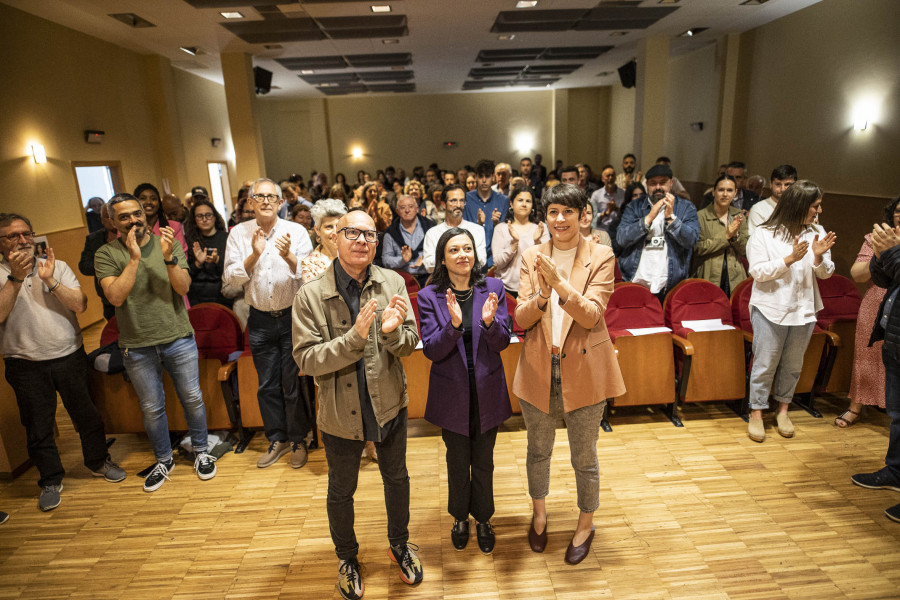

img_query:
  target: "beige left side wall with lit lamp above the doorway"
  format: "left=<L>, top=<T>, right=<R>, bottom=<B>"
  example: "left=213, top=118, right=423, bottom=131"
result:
left=0, top=5, right=158, bottom=233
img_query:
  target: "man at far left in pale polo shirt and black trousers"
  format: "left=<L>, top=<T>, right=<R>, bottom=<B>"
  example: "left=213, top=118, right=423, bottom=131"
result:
left=0, top=214, right=125, bottom=511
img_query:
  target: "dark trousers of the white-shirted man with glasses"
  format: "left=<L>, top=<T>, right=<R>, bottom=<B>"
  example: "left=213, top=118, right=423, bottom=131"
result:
left=247, top=307, right=310, bottom=443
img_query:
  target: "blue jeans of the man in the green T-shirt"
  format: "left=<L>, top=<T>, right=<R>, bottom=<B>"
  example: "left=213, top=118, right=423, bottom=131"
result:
left=123, top=335, right=207, bottom=461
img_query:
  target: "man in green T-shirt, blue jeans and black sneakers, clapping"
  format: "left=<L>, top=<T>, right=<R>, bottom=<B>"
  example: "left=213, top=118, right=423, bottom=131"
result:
left=94, top=194, right=216, bottom=492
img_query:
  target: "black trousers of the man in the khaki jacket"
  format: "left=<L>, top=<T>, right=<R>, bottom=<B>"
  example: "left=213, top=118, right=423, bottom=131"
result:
left=322, top=408, right=409, bottom=560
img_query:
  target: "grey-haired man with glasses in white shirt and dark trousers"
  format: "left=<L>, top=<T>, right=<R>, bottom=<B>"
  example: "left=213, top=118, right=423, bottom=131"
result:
left=222, top=178, right=312, bottom=469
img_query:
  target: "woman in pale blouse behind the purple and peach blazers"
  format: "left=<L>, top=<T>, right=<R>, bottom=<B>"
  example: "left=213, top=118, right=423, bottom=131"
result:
left=491, top=187, right=550, bottom=298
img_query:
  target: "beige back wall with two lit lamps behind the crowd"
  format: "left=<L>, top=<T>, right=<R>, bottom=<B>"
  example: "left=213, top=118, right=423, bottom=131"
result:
left=258, top=91, right=553, bottom=181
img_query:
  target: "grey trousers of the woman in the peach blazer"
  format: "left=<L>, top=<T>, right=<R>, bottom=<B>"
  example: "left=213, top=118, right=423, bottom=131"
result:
left=519, top=356, right=606, bottom=513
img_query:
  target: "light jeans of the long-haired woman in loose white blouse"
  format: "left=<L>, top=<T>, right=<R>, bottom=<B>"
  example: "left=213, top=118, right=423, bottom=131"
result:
left=750, top=306, right=816, bottom=410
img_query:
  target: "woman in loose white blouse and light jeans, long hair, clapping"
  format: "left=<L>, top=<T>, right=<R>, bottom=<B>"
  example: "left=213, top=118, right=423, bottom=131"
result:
left=747, top=180, right=836, bottom=442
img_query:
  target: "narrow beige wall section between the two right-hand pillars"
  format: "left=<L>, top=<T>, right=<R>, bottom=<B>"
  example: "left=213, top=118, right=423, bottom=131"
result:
left=660, top=44, right=719, bottom=181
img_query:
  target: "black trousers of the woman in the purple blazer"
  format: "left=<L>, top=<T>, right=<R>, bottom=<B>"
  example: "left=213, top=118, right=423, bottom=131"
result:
left=441, top=377, right=498, bottom=523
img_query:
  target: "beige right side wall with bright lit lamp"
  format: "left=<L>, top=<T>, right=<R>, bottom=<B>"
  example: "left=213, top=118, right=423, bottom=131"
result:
left=735, top=0, right=900, bottom=196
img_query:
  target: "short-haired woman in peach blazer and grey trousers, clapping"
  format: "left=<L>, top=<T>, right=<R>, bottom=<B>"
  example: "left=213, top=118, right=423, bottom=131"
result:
left=513, top=184, right=625, bottom=564
